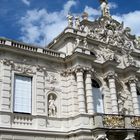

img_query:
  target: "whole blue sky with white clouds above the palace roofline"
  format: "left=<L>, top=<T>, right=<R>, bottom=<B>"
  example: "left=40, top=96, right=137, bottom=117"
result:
left=0, top=0, right=140, bottom=46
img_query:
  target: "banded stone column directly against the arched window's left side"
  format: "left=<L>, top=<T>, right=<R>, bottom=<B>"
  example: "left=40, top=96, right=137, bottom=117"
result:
left=85, top=71, right=94, bottom=114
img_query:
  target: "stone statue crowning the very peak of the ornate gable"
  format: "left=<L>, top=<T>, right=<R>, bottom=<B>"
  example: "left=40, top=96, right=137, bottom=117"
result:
left=100, top=0, right=110, bottom=17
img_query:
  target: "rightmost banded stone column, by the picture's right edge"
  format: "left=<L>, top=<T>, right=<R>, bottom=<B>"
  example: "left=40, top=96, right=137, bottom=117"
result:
left=129, top=78, right=140, bottom=115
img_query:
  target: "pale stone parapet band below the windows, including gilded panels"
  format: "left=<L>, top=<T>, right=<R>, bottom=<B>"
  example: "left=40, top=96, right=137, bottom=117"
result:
left=0, top=112, right=140, bottom=132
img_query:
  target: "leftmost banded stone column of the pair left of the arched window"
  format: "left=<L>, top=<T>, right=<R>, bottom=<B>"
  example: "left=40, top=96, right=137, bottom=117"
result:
left=76, top=68, right=86, bottom=113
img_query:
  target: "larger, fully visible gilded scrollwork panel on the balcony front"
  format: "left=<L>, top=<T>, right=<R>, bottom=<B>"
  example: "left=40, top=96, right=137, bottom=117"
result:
left=103, top=115, right=124, bottom=128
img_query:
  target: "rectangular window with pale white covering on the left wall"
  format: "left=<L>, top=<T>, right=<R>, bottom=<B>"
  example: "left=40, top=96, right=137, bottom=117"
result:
left=14, top=75, right=32, bottom=113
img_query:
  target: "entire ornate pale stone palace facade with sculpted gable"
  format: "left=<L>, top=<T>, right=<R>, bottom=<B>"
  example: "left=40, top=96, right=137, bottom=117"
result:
left=0, top=0, right=140, bottom=140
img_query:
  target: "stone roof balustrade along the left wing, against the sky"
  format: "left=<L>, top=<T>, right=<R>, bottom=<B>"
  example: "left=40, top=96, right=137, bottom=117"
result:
left=0, top=38, right=65, bottom=58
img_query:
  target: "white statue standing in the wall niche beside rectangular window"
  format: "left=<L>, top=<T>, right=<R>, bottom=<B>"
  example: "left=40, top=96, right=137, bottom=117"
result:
left=48, top=94, right=56, bottom=117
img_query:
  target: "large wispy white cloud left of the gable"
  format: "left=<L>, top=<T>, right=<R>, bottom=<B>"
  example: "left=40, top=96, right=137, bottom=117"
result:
left=19, top=0, right=76, bottom=46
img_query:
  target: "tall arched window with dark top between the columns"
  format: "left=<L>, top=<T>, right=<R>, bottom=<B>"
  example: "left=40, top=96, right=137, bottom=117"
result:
left=92, top=80, right=104, bottom=113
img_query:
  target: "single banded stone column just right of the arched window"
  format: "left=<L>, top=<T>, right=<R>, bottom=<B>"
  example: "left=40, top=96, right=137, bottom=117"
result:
left=108, top=73, right=118, bottom=114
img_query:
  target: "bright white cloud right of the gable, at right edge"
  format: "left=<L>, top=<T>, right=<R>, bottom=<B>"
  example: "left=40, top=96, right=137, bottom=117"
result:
left=112, top=11, right=140, bottom=36
